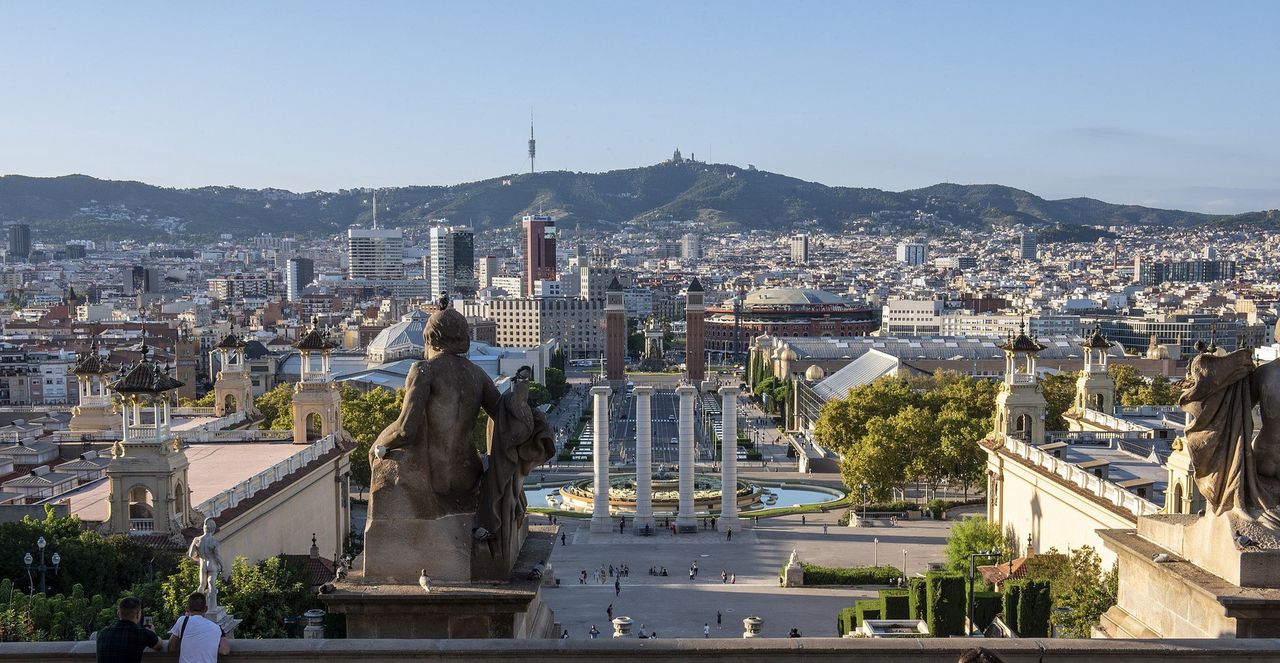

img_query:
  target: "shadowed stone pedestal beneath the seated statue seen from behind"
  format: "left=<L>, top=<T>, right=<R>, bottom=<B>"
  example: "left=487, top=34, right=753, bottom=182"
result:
left=320, top=526, right=558, bottom=639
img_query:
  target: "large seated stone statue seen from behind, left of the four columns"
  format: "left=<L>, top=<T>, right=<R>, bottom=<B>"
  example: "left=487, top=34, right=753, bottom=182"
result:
left=364, top=300, right=554, bottom=584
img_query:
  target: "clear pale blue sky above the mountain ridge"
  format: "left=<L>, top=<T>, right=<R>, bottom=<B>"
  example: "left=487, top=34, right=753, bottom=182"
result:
left=0, top=0, right=1280, bottom=211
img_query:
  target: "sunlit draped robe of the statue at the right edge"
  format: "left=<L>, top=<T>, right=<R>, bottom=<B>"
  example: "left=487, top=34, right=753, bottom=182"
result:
left=1179, top=349, right=1267, bottom=516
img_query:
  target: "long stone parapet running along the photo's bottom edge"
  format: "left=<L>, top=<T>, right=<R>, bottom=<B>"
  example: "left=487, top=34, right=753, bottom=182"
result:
left=10, top=637, right=1280, bottom=663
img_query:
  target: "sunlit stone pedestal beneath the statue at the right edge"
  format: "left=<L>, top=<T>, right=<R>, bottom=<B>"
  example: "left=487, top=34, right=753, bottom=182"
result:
left=1094, top=516, right=1280, bottom=639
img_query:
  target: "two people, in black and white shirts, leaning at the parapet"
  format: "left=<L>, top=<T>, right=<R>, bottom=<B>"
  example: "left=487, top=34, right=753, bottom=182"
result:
left=96, top=591, right=230, bottom=663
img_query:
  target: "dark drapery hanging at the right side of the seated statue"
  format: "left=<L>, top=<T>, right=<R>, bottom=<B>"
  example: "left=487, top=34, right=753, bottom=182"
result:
left=479, top=387, right=556, bottom=568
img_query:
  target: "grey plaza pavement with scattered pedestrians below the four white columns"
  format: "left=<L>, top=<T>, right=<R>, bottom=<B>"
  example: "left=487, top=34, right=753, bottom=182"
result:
left=532, top=512, right=951, bottom=639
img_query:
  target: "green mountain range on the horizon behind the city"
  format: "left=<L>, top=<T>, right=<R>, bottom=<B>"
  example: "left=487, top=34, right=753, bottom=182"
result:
left=0, top=160, right=1280, bottom=241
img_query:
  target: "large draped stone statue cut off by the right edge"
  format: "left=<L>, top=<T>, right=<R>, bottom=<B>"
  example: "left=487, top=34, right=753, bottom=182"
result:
left=1179, top=349, right=1280, bottom=527
